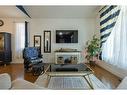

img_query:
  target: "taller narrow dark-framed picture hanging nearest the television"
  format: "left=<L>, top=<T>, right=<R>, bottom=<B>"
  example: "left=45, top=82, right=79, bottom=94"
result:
left=44, top=31, right=51, bottom=53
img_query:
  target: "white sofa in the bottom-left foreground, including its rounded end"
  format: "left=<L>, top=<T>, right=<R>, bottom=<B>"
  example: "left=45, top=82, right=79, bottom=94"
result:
left=0, top=73, right=46, bottom=89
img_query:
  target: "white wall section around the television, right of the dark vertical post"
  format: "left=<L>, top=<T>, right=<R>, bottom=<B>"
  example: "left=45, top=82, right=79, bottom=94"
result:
left=29, top=18, right=95, bottom=62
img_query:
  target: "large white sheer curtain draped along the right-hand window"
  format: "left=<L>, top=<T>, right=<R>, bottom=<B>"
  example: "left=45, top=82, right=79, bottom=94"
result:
left=102, top=6, right=127, bottom=69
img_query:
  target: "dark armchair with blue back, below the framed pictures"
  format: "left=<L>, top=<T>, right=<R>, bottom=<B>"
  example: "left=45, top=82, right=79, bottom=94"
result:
left=23, top=47, right=44, bottom=75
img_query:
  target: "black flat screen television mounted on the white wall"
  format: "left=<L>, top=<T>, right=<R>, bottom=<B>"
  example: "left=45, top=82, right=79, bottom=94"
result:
left=56, top=30, right=78, bottom=43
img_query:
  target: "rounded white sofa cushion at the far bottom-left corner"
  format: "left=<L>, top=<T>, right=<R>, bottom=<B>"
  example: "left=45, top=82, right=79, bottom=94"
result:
left=0, top=73, right=11, bottom=89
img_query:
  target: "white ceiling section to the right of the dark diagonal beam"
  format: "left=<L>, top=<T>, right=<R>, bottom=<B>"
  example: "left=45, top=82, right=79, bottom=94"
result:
left=24, top=6, right=97, bottom=18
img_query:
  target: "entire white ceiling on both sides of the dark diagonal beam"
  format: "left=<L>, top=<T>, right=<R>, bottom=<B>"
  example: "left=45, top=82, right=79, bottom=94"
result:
left=0, top=6, right=99, bottom=18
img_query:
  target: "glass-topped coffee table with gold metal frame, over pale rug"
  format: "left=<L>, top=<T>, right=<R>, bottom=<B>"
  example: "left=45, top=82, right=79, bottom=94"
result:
left=47, top=64, right=93, bottom=89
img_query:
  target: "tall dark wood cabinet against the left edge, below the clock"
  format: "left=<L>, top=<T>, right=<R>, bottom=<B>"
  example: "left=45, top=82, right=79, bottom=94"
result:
left=0, top=32, right=12, bottom=62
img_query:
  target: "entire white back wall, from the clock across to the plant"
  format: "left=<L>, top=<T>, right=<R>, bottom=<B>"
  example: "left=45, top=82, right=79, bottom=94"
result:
left=0, top=18, right=95, bottom=63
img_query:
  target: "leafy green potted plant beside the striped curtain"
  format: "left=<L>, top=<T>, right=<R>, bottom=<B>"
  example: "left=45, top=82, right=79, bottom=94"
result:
left=85, top=35, right=101, bottom=66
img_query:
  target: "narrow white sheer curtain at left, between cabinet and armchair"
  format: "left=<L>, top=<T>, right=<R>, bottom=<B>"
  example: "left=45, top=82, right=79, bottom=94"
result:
left=15, top=23, right=25, bottom=59
